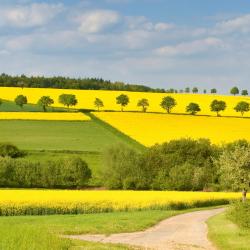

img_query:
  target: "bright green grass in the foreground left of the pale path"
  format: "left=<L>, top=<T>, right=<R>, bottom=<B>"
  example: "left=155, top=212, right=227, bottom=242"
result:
left=0, top=211, right=180, bottom=250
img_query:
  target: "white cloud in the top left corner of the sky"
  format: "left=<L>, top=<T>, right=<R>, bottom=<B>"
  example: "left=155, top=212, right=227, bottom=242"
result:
left=0, top=3, right=63, bottom=28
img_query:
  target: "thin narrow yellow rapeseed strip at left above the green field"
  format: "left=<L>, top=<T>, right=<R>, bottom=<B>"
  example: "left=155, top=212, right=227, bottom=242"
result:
left=0, top=112, right=90, bottom=121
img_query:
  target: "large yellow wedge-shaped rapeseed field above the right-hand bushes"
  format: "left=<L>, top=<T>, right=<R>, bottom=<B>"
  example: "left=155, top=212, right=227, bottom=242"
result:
left=94, top=112, right=250, bottom=146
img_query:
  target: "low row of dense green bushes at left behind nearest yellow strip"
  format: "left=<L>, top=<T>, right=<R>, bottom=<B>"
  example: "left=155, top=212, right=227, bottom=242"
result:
left=0, top=158, right=91, bottom=188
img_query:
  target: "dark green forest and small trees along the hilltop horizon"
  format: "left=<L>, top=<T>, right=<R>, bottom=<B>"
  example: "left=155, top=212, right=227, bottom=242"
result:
left=0, top=73, right=248, bottom=96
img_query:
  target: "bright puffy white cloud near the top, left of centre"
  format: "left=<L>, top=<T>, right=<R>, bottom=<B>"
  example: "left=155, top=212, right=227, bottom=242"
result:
left=77, top=10, right=120, bottom=33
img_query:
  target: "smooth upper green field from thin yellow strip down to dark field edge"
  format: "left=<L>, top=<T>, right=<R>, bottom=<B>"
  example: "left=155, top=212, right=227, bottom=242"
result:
left=0, top=120, right=135, bottom=152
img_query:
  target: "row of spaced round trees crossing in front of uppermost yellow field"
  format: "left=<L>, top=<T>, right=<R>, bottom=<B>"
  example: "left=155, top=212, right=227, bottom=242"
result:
left=0, top=94, right=250, bottom=116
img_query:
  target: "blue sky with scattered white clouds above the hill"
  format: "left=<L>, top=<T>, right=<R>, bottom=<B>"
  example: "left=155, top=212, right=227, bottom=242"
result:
left=0, top=0, right=250, bottom=92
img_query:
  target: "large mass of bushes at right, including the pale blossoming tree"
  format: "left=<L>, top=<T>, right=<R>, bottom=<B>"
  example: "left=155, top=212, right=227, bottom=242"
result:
left=104, top=139, right=250, bottom=191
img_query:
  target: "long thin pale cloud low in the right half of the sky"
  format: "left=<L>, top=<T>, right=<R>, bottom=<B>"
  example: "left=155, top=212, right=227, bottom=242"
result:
left=155, top=37, right=224, bottom=56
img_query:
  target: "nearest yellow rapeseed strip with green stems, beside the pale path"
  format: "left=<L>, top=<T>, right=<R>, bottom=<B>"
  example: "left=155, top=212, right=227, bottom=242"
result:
left=0, top=189, right=240, bottom=215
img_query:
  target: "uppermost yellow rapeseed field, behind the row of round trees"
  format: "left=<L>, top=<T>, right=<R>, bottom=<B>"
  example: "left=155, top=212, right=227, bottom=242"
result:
left=0, top=87, right=250, bottom=116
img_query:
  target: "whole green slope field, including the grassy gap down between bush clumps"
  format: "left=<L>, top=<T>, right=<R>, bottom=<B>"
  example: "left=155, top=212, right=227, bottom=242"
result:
left=0, top=119, right=144, bottom=186
